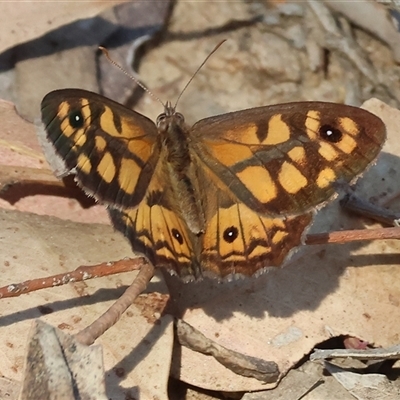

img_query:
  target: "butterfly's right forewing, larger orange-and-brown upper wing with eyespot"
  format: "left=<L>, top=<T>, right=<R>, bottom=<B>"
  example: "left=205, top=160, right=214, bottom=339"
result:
left=191, top=102, right=386, bottom=215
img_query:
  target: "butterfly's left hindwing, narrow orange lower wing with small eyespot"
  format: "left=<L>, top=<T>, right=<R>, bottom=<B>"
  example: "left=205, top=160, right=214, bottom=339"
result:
left=109, top=170, right=200, bottom=279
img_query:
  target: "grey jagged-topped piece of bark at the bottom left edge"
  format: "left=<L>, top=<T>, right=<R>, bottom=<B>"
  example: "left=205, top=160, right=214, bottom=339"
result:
left=21, top=320, right=108, bottom=400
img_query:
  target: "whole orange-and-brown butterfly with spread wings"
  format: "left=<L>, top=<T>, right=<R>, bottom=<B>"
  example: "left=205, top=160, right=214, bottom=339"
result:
left=41, top=89, right=386, bottom=280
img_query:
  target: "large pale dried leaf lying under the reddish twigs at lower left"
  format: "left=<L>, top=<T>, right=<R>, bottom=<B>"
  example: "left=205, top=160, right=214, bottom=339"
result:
left=0, top=209, right=173, bottom=399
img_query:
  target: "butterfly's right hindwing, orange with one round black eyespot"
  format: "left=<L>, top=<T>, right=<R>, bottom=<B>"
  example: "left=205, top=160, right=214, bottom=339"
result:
left=195, top=169, right=313, bottom=277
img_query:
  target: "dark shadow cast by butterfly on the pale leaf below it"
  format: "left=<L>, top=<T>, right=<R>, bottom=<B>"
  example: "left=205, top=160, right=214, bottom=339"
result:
left=164, top=244, right=398, bottom=321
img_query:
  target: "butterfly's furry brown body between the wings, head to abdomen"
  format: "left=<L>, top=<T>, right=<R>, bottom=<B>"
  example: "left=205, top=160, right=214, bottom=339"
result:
left=157, top=102, right=205, bottom=234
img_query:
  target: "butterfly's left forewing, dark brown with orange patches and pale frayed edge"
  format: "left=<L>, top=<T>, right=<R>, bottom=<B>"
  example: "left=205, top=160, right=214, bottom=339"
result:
left=42, top=89, right=160, bottom=207
